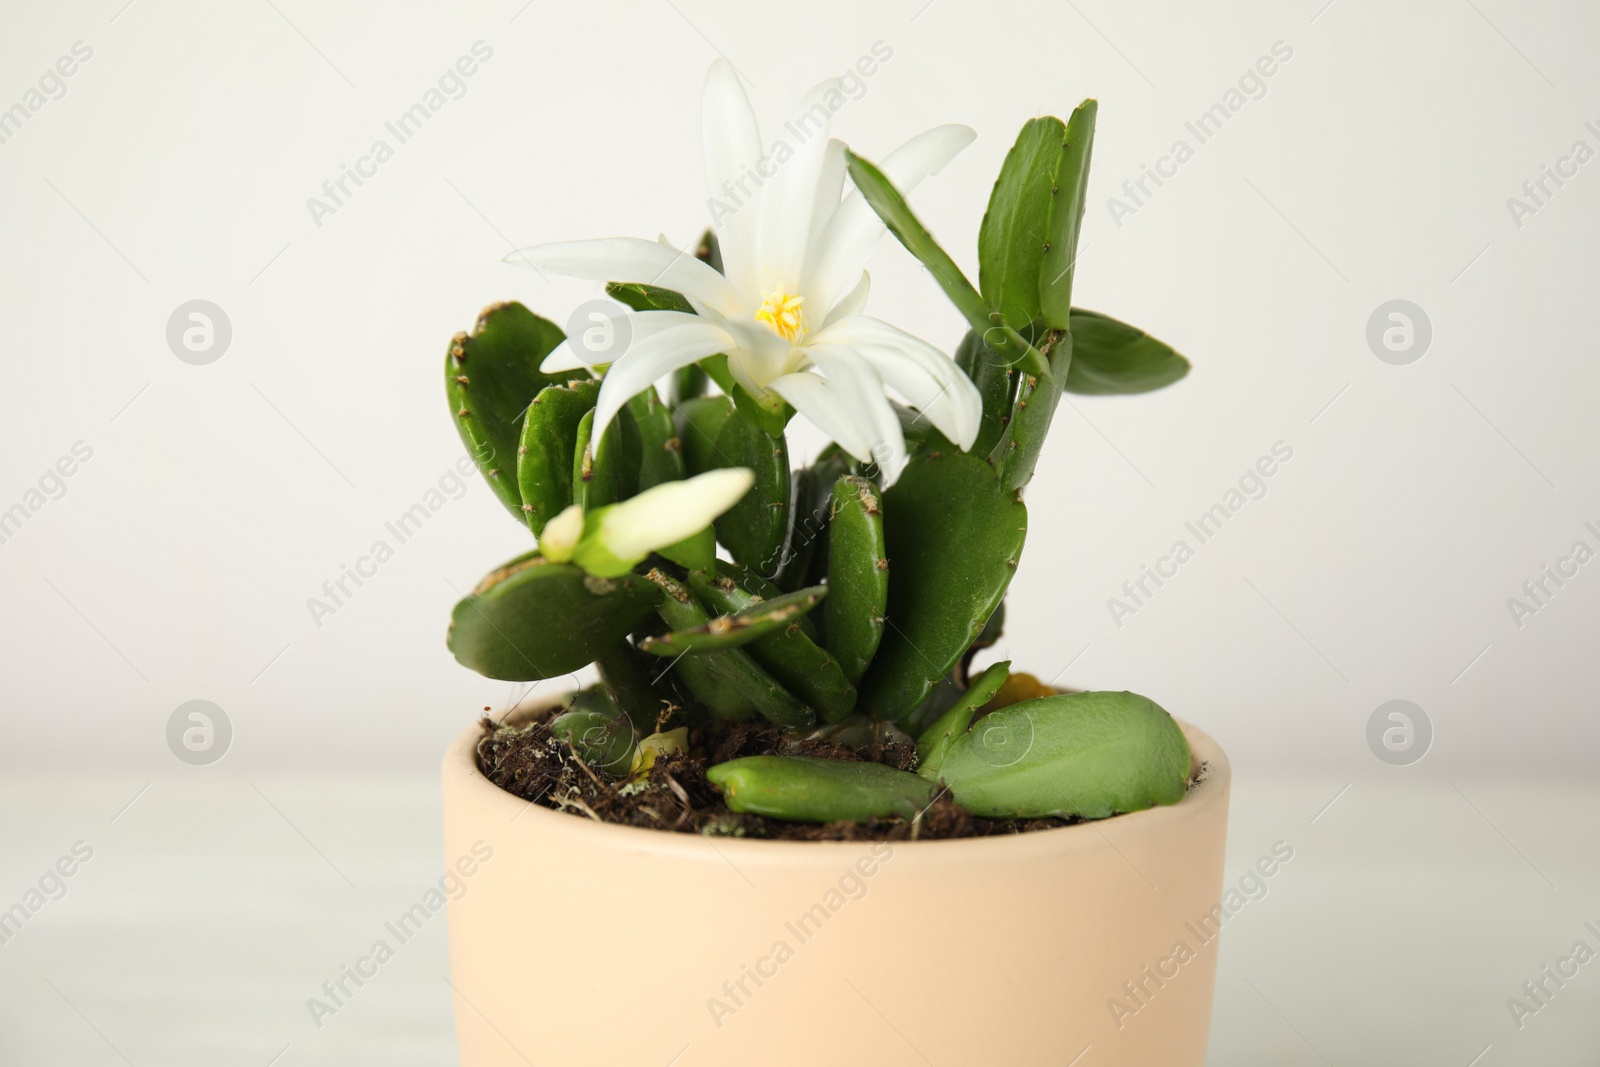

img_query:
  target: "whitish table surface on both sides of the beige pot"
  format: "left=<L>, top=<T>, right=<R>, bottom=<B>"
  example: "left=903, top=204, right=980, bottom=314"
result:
left=0, top=765, right=1600, bottom=1067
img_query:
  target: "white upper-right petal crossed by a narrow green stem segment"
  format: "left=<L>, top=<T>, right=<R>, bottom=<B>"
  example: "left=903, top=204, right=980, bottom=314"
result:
left=803, top=125, right=978, bottom=314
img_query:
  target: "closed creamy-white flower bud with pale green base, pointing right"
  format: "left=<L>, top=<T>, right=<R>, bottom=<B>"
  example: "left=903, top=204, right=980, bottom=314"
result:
left=539, top=467, right=755, bottom=577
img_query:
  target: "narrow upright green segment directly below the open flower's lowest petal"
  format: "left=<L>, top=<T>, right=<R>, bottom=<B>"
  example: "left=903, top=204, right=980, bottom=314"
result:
left=824, top=475, right=890, bottom=683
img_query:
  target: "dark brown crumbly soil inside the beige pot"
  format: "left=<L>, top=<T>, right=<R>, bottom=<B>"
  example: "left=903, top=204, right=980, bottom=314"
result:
left=478, top=709, right=1164, bottom=841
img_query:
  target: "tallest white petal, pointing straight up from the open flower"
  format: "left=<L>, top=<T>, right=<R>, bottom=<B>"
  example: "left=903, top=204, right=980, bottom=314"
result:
left=701, top=59, right=765, bottom=293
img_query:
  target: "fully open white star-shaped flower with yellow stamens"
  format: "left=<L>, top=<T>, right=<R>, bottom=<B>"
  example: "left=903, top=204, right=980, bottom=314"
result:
left=507, top=61, right=982, bottom=483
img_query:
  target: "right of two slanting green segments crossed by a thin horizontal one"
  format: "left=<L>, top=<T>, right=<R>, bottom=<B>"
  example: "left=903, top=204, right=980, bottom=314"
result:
left=690, top=560, right=856, bottom=723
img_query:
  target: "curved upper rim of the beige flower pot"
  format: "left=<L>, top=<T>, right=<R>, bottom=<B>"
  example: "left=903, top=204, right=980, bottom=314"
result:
left=443, top=718, right=1232, bottom=867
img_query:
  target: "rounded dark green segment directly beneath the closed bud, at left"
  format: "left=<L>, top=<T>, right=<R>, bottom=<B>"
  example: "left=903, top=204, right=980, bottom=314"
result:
left=446, top=553, right=661, bottom=681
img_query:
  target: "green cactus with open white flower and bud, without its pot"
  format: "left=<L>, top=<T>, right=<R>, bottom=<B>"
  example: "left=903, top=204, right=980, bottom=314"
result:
left=446, top=64, right=1190, bottom=822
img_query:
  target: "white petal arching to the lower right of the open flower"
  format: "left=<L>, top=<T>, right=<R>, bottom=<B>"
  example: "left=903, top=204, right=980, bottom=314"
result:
left=806, top=315, right=984, bottom=450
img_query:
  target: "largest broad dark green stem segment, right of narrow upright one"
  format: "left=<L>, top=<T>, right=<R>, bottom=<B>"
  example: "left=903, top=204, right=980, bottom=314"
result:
left=859, top=453, right=1027, bottom=720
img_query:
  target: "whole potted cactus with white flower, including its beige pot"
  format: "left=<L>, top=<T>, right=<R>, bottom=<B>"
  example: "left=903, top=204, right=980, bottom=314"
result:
left=443, top=62, right=1229, bottom=1067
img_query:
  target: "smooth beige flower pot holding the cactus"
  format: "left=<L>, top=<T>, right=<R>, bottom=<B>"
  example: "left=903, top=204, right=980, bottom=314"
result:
left=443, top=713, right=1229, bottom=1067
